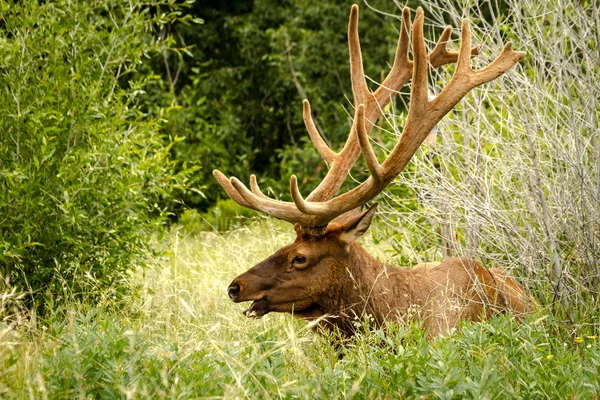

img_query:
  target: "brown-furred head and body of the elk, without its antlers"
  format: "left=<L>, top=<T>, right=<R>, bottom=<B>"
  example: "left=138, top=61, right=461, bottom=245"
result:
left=226, top=210, right=535, bottom=336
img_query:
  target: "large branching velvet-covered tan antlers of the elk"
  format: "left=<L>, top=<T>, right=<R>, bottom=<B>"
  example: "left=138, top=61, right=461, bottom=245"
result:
left=213, top=5, right=525, bottom=227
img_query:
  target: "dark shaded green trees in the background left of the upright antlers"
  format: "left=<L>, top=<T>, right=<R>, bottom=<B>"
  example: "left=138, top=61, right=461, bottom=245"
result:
left=145, top=0, right=414, bottom=212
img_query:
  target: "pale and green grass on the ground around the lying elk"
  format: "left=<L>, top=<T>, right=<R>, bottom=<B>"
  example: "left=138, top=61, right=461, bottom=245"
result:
left=0, top=222, right=600, bottom=399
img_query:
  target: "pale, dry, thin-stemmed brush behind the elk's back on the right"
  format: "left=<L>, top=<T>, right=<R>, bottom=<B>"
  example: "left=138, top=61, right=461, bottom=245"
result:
left=382, top=0, right=600, bottom=329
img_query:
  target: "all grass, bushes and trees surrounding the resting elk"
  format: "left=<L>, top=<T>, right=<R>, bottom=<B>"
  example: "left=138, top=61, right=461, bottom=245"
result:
left=0, top=0, right=600, bottom=398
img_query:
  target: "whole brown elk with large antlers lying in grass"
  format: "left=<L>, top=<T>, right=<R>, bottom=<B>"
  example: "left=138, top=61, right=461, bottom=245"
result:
left=213, top=5, right=533, bottom=337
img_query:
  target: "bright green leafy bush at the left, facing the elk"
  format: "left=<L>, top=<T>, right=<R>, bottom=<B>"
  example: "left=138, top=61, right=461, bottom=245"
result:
left=0, top=0, right=191, bottom=303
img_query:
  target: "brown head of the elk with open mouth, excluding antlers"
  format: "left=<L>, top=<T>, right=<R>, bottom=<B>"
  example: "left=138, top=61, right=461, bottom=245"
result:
left=228, top=204, right=377, bottom=319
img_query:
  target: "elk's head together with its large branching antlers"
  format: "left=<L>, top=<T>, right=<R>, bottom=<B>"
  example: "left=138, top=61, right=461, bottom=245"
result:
left=213, top=5, right=524, bottom=318
